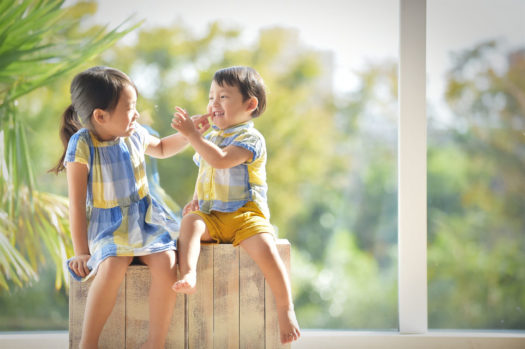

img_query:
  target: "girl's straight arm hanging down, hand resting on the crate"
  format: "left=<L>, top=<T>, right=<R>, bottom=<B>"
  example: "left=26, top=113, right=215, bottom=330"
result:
left=66, top=162, right=91, bottom=277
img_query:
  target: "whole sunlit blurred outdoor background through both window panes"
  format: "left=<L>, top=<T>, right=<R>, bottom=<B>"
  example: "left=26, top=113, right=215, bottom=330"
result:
left=0, top=0, right=525, bottom=331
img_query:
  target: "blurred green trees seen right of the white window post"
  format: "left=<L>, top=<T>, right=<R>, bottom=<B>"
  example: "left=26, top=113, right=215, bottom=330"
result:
left=428, top=42, right=525, bottom=329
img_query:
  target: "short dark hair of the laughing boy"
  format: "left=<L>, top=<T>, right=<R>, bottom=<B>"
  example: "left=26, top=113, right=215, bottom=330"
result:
left=213, top=66, right=266, bottom=118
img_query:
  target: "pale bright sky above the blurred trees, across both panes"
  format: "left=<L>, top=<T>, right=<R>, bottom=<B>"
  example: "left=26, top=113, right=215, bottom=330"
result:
left=66, top=0, right=525, bottom=100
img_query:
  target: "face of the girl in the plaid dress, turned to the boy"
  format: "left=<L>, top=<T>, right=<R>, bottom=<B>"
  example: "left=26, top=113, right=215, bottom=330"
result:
left=102, top=85, right=139, bottom=139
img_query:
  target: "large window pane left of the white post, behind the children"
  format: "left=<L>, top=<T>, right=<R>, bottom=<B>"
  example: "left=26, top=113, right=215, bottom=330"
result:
left=0, top=0, right=398, bottom=330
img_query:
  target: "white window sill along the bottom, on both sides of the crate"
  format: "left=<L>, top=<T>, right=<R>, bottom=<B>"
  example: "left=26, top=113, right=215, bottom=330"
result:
left=0, top=330, right=525, bottom=349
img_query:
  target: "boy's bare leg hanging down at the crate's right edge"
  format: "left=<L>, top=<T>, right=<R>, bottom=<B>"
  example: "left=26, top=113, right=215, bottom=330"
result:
left=240, top=233, right=301, bottom=344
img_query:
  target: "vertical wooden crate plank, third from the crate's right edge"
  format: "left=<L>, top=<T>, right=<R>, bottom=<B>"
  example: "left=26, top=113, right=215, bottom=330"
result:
left=213, top=244, right=239, bottom=349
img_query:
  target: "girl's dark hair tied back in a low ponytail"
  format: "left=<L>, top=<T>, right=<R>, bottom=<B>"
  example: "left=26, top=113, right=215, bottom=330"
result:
left=49, top=67, right=137, bottom=174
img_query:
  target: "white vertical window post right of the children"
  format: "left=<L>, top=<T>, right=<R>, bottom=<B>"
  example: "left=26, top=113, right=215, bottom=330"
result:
left=397, top=0, right=428, bottom=334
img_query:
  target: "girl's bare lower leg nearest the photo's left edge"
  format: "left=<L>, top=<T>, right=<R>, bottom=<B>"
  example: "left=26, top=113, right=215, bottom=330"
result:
left=79, top=257, right=132, bottom=349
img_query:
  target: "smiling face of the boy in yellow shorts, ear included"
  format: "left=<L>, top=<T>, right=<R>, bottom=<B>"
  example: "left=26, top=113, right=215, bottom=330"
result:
left=208, top=81, right=257, bottom=130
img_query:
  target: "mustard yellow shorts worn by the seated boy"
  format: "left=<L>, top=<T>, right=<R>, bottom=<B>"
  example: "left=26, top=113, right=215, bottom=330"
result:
left=191, top=201, right=275, bottom=246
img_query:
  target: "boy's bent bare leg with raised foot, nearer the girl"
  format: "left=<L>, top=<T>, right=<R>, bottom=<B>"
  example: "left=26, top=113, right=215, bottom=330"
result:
left=172, top=213, right=211, bottom=294
